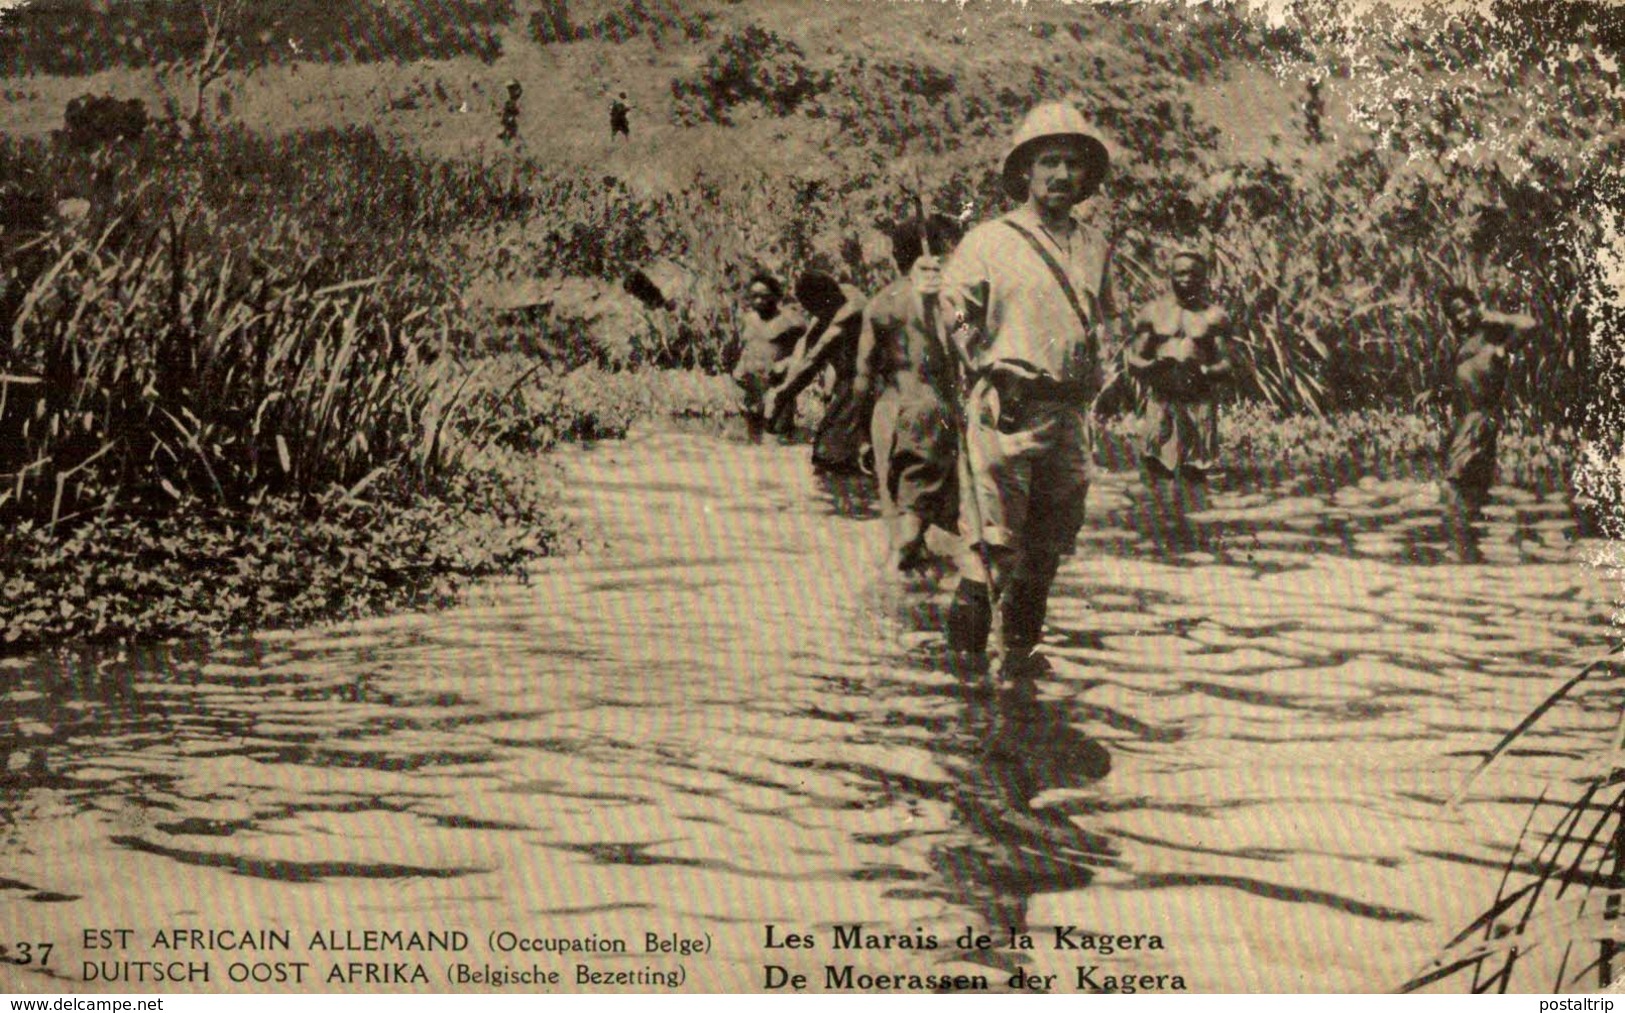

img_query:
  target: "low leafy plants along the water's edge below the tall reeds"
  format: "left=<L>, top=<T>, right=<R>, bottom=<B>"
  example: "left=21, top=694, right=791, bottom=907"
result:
left=0, top=455, right=561, bottom=652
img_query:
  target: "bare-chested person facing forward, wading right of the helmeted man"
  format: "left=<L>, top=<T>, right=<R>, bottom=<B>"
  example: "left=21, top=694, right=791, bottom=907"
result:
left=1128, top=250, right=1230, bottom=486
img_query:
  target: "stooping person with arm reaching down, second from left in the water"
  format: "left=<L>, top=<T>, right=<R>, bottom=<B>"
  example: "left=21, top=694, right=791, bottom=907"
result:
left=767, top=272, right=871, bottom=475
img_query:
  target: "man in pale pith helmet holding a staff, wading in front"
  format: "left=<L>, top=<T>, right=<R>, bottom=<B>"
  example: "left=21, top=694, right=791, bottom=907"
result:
left=921, top=102, right=1110, bottom=681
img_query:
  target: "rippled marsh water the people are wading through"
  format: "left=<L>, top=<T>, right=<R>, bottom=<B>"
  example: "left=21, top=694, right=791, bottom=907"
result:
left=0, top=431, right=1619, bottom=992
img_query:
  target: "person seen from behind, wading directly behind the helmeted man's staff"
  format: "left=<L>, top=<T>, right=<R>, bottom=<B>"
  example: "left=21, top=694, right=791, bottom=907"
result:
left=853, top=215, right=960, bottom=571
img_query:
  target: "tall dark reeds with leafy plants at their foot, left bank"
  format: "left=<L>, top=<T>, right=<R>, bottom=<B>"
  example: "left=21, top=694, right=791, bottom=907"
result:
left=0, top=134, right=567, bottom=649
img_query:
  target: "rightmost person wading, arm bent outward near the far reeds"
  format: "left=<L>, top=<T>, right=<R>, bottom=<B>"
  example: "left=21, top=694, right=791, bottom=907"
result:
left=1443, top=285, right=1536, bottom=530
